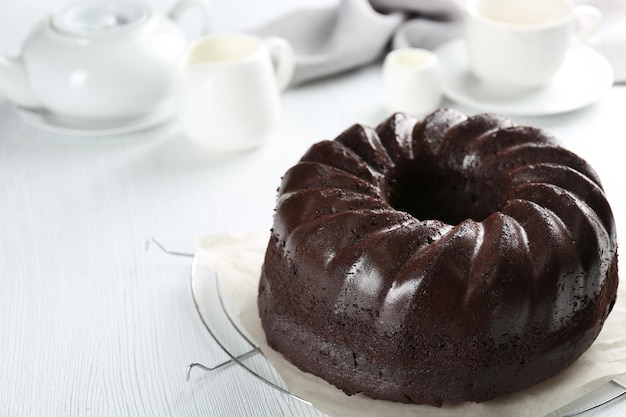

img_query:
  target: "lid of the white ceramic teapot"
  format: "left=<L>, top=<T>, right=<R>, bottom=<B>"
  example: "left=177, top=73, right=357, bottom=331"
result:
left=50, top=0, right=151, bottom=36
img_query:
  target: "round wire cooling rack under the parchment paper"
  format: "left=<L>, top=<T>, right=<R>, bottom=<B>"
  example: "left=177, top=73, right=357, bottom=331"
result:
left=146, top=238, right=626, bottom=417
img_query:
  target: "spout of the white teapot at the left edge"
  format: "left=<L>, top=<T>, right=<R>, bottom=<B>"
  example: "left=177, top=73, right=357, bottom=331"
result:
left=0, top=55, right=41, bottom=108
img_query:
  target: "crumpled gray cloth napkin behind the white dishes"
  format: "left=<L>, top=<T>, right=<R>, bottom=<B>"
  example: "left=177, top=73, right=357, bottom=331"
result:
left=251, top=0, right=626, bottom=84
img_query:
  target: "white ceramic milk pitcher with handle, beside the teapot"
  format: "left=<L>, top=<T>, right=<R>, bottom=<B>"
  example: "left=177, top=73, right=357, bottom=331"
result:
left=178, top=33, right=294, bottom=153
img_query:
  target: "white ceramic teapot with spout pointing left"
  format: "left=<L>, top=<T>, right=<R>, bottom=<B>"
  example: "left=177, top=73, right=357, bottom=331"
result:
left=0, top=0, right=208, bottom=123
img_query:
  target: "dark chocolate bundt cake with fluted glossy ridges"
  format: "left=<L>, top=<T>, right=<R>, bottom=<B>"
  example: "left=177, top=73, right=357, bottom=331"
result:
left=258, top=110, right=618, bottom=405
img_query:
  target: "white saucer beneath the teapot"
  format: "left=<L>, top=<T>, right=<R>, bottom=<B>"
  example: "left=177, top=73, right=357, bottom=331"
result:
left=15, top=104, right=174, bottom=136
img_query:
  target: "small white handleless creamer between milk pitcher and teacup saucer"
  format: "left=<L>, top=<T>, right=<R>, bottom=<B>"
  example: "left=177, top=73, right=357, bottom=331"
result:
left=383, top=48, right=441, bottom=116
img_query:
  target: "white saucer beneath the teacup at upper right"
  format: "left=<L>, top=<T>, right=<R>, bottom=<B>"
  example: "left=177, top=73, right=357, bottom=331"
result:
left=435, top=39, right=613, bottom=116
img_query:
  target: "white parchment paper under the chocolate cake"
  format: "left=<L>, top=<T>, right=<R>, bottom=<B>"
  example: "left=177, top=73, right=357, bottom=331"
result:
left=198, top=233, right=626, bottom=417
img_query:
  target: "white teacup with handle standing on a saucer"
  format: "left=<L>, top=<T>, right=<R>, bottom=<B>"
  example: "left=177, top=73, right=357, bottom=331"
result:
left=465, top=0, right=601, bottom=89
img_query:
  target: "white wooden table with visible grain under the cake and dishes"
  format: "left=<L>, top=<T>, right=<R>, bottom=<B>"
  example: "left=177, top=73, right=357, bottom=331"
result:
left=0, top=0, right=626, bottom=417
